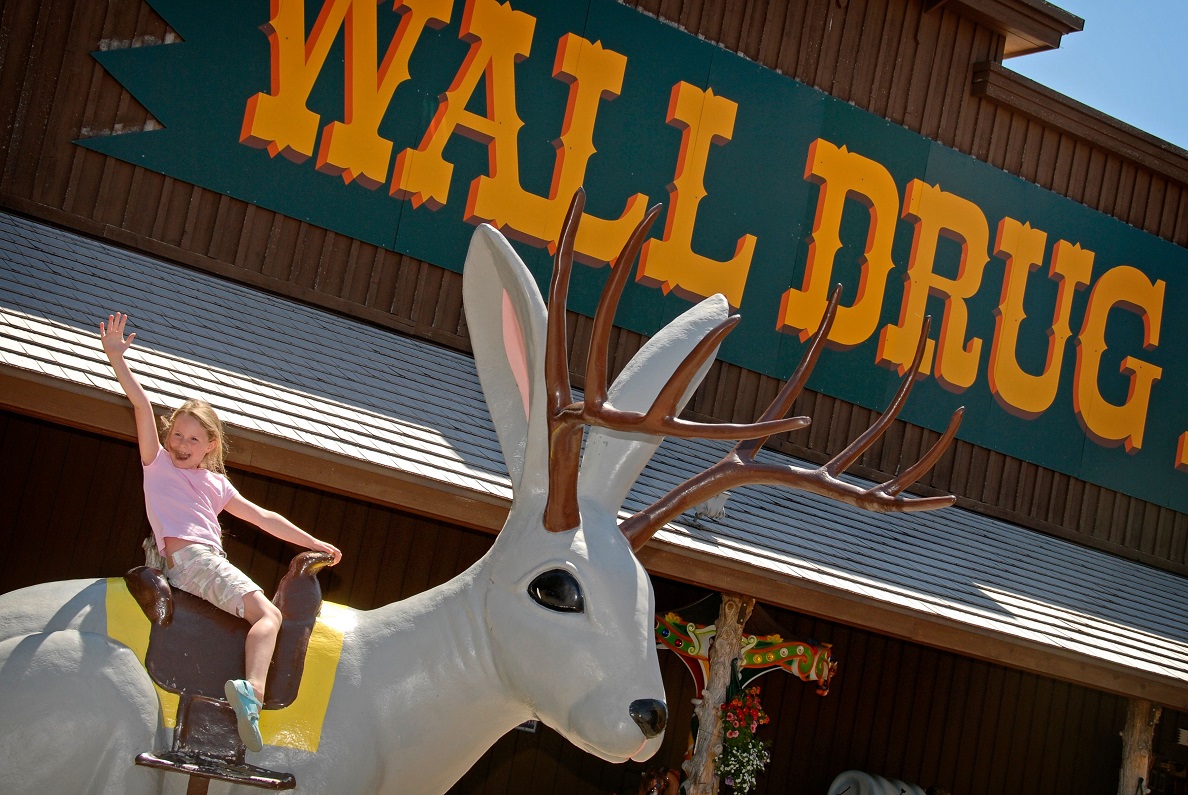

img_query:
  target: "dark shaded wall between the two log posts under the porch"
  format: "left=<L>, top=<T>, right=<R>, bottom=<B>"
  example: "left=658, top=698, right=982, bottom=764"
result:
left=758, top=608, right=1125, bottom=795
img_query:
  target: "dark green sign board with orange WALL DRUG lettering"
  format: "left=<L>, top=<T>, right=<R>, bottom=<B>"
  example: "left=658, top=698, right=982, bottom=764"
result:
left=78, top=0, right=1188, bottom=511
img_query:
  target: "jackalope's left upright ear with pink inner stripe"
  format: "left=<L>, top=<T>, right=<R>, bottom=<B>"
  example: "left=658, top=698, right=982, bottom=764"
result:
left=462, top=223, right=549, bottom=493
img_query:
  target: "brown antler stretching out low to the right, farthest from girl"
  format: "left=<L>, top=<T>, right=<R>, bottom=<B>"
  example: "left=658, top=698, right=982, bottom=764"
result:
left=619, top=285, right=965, bottom=550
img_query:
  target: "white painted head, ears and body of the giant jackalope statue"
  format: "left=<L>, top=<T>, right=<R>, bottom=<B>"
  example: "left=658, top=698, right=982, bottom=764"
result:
left=0, top=226, right=728, bottom=795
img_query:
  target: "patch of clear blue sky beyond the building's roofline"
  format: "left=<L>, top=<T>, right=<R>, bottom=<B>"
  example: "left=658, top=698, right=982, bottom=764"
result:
left=1003, top=0, right=1188, bottom=149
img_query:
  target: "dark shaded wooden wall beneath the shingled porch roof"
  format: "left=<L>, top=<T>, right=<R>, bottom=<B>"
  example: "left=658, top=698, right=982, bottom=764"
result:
left=0, top=412, right=1126, bottom=795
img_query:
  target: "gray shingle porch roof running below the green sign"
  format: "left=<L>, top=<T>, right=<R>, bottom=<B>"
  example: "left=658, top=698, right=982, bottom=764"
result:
left=0, top=214, right=1188, bottom=683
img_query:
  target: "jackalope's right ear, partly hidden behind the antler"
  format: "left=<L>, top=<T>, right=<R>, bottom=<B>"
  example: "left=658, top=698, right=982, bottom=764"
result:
left=577, top=295, right=729, bottom=516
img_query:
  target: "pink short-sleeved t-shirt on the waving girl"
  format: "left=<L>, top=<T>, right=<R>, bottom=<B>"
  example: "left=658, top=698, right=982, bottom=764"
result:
left=144, top=447, right=239, bottom=555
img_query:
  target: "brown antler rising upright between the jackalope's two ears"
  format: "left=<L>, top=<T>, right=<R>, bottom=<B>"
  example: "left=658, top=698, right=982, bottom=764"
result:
left=544, top=189, right=809, bottom=532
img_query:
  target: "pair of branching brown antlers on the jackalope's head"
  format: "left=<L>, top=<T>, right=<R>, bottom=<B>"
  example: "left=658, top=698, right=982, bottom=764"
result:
left=544, top=189, right=965, bottom=541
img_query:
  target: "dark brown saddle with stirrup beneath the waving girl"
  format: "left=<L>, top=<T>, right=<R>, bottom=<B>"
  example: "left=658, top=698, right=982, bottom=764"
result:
left=124, top=551, right=333, bottom=789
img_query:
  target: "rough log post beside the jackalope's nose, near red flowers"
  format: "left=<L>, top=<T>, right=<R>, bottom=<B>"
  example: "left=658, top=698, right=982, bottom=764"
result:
left=684, top=593, right=754, bottom=795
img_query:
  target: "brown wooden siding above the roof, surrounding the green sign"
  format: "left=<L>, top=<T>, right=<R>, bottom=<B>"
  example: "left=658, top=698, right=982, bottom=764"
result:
left=0, top=0, right=1188, bottom=573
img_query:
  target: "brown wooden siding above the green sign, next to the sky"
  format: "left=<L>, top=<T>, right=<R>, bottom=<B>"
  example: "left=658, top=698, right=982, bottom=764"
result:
left=626, top=0, right=1188, bottom=246
